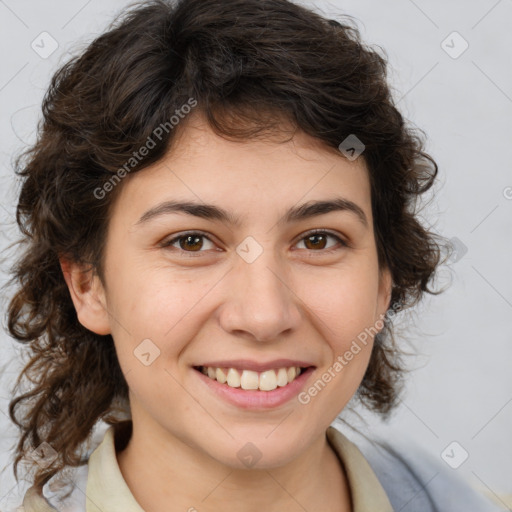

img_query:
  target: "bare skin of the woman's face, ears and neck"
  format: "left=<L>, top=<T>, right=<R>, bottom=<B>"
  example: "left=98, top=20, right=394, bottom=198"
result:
left=62, top=114, right=392, bottom=512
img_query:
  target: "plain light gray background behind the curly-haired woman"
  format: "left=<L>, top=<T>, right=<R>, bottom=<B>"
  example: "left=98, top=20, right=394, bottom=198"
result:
left=0, top=0, right=512, bottom=510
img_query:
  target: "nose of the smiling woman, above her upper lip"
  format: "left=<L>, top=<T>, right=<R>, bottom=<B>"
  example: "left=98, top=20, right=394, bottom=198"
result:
left=219, top=250, right=301, bottom=342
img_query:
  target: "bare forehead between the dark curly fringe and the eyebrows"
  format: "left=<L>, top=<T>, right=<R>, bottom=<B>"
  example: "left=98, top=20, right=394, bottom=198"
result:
left=111, top=116, right=371, bottom=229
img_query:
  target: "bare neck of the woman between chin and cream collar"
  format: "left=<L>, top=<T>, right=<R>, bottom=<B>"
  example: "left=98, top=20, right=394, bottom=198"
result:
left=117, top=420, right=352, bottom=512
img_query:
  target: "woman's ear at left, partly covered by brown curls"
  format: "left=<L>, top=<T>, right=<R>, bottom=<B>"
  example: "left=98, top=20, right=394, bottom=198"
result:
left=59, top=258, right=111, bottom=335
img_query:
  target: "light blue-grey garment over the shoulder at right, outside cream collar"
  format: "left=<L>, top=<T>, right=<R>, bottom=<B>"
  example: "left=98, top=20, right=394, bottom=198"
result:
left=339, top=429, right=503, bottom=512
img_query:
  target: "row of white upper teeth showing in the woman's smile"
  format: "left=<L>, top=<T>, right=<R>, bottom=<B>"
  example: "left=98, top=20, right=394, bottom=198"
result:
left=201, top=366, right=301, bottom=391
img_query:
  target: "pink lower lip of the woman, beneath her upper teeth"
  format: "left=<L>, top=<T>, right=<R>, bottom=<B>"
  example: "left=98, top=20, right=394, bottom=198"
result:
left=194, top=366, right=315, bottom=409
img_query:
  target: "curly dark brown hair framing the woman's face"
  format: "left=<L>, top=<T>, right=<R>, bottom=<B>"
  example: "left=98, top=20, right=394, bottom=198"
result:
left=8, top=0, right=443, bottom=489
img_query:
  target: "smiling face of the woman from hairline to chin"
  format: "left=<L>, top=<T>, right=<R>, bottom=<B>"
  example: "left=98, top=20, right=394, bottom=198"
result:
left=68, top=114, right=391, bottom=467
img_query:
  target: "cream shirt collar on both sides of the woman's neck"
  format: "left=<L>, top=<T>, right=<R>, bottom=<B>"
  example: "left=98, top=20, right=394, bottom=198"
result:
left=23, top=426, right=393, bottom=512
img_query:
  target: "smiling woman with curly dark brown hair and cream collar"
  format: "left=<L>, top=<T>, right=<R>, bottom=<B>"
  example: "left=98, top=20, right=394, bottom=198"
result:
left=4, top=0, right=500, bottom=512
